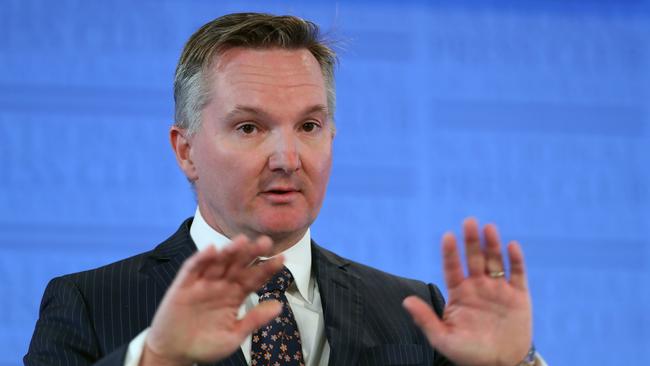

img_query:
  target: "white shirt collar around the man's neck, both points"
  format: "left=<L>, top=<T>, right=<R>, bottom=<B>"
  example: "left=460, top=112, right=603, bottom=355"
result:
left=190, top=207, right=313, bottom=303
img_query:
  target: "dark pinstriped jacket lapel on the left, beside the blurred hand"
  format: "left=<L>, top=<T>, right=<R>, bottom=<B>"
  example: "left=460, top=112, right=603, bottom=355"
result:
left=140, top=219, right=247, bottom=366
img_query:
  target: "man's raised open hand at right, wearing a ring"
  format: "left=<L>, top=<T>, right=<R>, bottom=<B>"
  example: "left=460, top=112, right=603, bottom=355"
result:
left=405, top=220, right=532, bottom=365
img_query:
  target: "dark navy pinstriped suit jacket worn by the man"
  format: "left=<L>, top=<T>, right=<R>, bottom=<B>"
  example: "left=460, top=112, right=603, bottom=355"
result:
left=24, top=219, right=449, bottom=366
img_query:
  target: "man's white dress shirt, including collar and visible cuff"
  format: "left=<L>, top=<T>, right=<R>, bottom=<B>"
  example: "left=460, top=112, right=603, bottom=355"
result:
left=124, top=208, right=330, bottom=366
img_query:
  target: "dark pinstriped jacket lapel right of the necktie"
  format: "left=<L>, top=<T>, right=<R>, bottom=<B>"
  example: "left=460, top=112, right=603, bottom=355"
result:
left=312, top=241, right=363, bottom=366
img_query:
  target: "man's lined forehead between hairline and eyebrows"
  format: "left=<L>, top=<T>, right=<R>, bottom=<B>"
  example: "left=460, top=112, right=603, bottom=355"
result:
left=210, top=47, right=327, bottom=110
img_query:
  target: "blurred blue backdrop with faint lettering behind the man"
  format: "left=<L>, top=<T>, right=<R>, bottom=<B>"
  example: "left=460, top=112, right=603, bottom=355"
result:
left=0, top=0, right=650, bottom=366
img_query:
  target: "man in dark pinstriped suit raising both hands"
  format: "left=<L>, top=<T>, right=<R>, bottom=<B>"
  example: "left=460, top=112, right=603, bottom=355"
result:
left=24, top=13, right=535, bottom=365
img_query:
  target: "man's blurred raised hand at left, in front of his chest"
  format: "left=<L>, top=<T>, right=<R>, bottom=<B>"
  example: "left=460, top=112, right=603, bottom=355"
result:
left=140, top=235, right=283, bottom=365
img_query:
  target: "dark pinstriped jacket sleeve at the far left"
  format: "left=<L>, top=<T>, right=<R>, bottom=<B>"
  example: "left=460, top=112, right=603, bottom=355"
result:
left=23, top=277, right=127, bottom=366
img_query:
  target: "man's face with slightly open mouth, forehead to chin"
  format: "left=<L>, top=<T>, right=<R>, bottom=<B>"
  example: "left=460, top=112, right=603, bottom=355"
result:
left=185, top=48, right=334, bottom=245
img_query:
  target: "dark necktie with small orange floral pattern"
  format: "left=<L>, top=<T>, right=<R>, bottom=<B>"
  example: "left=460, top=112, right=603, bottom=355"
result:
left=251, top=267, right=305, bottom=366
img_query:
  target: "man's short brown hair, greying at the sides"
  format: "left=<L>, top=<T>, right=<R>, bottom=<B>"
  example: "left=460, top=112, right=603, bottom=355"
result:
left=174, top=13, right=336, bottom=135
